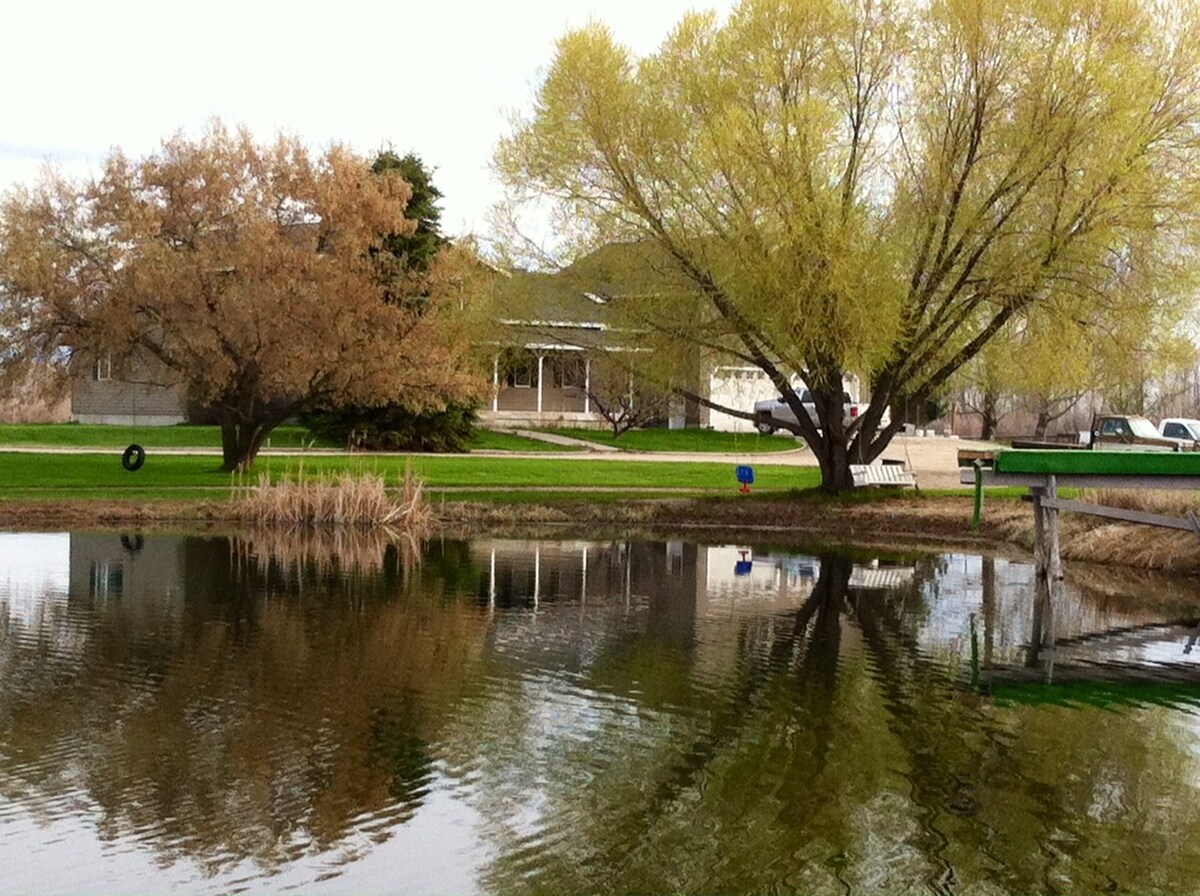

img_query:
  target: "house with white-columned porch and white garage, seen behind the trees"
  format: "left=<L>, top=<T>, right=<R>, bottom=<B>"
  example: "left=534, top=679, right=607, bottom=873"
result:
left=72, top=243, right=796, bottom=432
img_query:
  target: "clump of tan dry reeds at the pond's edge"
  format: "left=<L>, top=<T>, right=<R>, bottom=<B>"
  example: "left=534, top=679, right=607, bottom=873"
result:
left=234, top=468, right=430, bottom=539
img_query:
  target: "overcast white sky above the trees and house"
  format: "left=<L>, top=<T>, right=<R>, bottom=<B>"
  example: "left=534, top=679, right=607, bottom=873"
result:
left=0, top=0, right=732, bottom=242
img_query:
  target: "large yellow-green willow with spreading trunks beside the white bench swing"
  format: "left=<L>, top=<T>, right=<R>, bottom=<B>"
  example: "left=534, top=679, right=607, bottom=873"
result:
left=497, top=0, right=1200, bottom=491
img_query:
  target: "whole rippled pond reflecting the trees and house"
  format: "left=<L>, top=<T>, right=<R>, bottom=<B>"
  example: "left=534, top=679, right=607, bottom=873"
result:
left=0, top=533, right=1200, bottom=894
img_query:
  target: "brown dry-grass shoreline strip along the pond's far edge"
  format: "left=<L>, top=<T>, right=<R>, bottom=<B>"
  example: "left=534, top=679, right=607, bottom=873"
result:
left=0, top=495, right=1200, bottom=576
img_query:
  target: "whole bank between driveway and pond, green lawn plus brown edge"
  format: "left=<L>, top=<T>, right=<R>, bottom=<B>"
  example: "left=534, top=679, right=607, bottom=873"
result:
left=0, top=429, right=1200, bottom=573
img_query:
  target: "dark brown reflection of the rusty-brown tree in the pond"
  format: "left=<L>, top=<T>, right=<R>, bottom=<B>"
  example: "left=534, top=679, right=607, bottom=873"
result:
left=0, top=539, right=487, bottom=872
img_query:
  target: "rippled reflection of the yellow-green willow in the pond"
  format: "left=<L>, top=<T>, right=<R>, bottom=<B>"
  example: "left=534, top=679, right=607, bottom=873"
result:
left=475, top=555, right=1200, bottom=894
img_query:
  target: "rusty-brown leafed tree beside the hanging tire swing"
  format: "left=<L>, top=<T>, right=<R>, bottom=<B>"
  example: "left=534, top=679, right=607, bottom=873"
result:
left=0, top=124, right=487, bottom=470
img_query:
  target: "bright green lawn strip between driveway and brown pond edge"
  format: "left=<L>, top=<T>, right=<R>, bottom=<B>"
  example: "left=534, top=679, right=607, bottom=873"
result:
left=0, top=449, right=820, bottom=499
